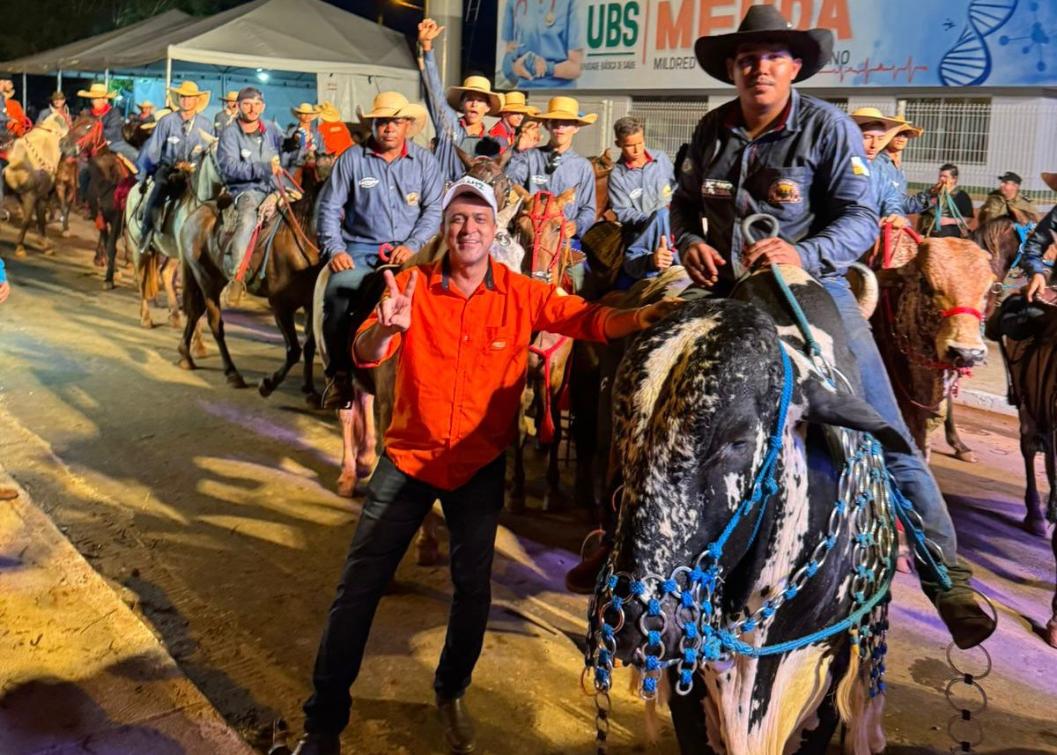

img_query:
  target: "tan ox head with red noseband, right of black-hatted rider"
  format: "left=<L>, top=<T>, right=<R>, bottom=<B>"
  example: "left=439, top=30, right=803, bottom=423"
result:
left=914, top=238, right=995, bottom=367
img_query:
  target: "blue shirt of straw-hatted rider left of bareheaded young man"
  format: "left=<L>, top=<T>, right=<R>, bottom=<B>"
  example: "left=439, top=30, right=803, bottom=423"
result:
left=506, top=143, right=597, bottom=236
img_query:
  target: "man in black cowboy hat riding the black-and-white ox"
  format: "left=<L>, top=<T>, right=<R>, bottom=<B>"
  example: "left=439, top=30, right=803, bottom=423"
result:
left=671, top=5, right=995, bottom=647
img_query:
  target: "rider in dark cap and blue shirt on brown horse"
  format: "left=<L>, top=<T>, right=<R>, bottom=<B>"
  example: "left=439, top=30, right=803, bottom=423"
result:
left=217, top=87, right=292, bottom=287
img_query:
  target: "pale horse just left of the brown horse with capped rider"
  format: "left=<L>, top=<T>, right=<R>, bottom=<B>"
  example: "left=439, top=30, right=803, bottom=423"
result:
left=124, top=136, right=224, bottom=336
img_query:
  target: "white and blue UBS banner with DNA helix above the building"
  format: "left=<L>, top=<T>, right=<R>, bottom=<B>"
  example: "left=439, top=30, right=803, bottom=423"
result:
left=496, top=0, right=1057, bottom=91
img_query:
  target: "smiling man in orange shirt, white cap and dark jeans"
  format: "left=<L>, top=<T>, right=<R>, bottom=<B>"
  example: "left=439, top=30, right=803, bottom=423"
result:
left=296, top=177, right=678, bottom=755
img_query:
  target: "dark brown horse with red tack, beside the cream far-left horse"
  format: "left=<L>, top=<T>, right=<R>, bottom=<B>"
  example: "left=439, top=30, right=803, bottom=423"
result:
left=61, top=112, right=135, bottom=290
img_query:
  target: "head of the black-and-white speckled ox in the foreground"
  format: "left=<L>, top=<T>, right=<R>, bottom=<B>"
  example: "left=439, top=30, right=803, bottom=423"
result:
left=596, top=291, right=907, bottom=663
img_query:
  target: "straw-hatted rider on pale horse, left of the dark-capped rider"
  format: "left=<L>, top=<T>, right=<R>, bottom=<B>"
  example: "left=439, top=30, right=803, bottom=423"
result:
left=138, top=81, right=212, bottom=254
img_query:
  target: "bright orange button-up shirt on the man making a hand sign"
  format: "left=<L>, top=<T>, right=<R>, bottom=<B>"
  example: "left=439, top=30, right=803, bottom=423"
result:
left=357, top=255, right=613, bottom=491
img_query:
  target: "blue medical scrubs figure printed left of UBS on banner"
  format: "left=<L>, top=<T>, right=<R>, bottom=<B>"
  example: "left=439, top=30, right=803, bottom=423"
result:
left=500, top=0, right=585, bottom=89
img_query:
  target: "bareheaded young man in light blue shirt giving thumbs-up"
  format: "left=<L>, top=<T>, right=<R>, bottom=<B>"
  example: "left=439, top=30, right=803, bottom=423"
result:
left=609, top=115, right=679, bottom=289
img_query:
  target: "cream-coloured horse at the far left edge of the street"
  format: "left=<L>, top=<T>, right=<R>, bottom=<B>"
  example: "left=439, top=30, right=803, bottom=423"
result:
left=0, top=113, right=69, bottom=257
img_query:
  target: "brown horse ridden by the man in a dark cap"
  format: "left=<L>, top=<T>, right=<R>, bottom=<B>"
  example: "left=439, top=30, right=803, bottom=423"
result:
left=177, top=159, right=333, bottom=397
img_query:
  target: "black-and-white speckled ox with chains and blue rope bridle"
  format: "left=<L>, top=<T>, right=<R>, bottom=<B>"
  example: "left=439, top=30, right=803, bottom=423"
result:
left=586, top=265, right=908, bottom=755
